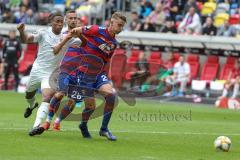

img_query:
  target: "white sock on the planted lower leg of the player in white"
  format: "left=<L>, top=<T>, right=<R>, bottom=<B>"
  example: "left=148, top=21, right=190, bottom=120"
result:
left=33, top=102, right=49, bottom=127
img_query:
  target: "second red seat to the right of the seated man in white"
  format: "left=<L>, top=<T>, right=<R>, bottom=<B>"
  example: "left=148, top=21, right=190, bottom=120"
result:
left=200, top=63, right=219, bottom=81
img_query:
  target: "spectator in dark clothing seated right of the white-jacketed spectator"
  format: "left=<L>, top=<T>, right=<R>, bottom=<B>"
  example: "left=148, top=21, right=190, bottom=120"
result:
left=202, top=17, right=217, bottom=36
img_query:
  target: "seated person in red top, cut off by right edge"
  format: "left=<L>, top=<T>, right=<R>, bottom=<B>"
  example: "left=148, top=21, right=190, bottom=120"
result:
left=220, top=59, right=240, bottom=98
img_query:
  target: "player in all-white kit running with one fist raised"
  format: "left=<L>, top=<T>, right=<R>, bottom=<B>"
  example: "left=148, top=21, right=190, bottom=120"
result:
left=17, top=12, right=72, bottom=135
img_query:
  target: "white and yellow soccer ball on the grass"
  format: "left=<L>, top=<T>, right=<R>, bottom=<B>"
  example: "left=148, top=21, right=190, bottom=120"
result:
left=214, top=136, right=231, bottom=152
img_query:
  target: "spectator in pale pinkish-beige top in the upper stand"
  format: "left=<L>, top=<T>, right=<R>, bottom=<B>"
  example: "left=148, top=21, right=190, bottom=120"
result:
left=149, top=3, right=165, bottom=31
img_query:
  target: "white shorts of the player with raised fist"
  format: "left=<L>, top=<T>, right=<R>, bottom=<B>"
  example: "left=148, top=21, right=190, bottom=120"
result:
left=26, top=68, right=52, bottom=92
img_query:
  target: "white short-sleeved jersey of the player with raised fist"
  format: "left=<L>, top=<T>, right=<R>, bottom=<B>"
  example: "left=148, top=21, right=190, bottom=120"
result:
left=32, top=27, right=63, bottom=74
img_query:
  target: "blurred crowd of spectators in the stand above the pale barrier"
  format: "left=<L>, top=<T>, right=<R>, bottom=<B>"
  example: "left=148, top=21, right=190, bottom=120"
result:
left=0, top=0, right=240, bottom=37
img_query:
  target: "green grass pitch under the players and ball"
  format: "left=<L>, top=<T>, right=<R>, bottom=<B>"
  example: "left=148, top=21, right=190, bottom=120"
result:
left=0, top=92, right=240, bottom=160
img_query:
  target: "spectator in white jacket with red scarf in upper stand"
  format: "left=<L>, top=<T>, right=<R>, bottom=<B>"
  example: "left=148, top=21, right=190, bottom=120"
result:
left=178, top=7, right=201, bottom=34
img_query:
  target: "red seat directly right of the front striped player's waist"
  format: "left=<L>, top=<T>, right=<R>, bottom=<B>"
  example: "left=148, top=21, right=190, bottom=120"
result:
left=109, top=53, right=127, bottom=88
